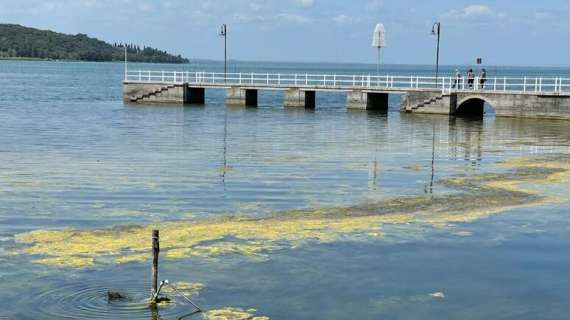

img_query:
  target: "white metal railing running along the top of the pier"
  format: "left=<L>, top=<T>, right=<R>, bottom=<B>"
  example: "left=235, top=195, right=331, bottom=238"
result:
left=125, top=70, right=570, bottom=94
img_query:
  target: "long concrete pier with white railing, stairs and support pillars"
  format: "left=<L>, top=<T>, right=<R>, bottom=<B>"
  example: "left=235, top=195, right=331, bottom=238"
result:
left=123, top=70, right=570, bottom=119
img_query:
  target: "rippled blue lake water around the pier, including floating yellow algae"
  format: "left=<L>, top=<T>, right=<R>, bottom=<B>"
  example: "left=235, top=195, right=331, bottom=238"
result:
left=0, top=61, right=570, bottom=319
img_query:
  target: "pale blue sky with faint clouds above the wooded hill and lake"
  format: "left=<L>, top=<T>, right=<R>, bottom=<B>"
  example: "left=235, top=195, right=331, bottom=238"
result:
left=0, top=0, right=570, bottom=66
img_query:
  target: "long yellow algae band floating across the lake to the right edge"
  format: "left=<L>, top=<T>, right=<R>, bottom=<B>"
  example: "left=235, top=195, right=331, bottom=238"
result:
left=16, top=156, right=570, bottom=267
